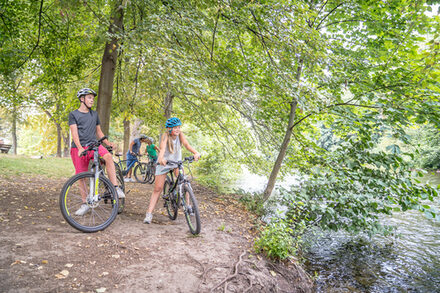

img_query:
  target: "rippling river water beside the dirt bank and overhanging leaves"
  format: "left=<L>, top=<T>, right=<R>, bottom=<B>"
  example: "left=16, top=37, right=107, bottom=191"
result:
left=240, top=171, right=440, bottom=292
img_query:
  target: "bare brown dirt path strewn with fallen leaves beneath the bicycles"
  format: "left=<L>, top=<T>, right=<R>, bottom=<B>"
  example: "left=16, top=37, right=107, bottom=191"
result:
left=0, top=177, right=312, bottom=292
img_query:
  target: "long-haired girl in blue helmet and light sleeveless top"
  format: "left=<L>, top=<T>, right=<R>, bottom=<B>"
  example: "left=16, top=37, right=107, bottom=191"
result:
left=144, top=117, right=200, bottom=224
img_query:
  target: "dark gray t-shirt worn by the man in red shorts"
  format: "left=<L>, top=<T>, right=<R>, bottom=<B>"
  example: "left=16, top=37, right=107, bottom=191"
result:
left=69, top=110, right=101, bottom=148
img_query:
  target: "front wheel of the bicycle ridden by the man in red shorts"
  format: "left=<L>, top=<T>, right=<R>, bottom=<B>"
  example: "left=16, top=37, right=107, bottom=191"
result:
left=60, top=172, right=118, bottom=233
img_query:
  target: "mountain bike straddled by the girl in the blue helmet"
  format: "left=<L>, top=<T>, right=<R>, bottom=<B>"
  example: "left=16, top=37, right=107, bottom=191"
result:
left=162, top=156, right=201, bottom=235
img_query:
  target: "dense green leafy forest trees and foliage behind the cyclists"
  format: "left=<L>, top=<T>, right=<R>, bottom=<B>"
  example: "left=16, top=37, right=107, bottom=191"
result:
left=0, top=0, right=440, bottom=257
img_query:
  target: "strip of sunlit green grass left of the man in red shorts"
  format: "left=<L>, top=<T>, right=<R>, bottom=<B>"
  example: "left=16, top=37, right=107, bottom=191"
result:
left=0, top=154, right=75, bottom=178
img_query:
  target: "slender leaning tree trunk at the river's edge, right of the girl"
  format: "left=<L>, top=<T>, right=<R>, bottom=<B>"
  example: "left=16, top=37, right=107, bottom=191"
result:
left=263, top=59, right=304, bottom=201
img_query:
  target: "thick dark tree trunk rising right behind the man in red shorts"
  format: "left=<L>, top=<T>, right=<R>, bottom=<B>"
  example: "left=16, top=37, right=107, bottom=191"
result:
left=97, top=0, right=124, bottom=135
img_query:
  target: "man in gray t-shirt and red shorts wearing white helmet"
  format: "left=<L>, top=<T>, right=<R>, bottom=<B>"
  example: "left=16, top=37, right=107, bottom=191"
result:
left=69, top=88, right=125, bottom=216
